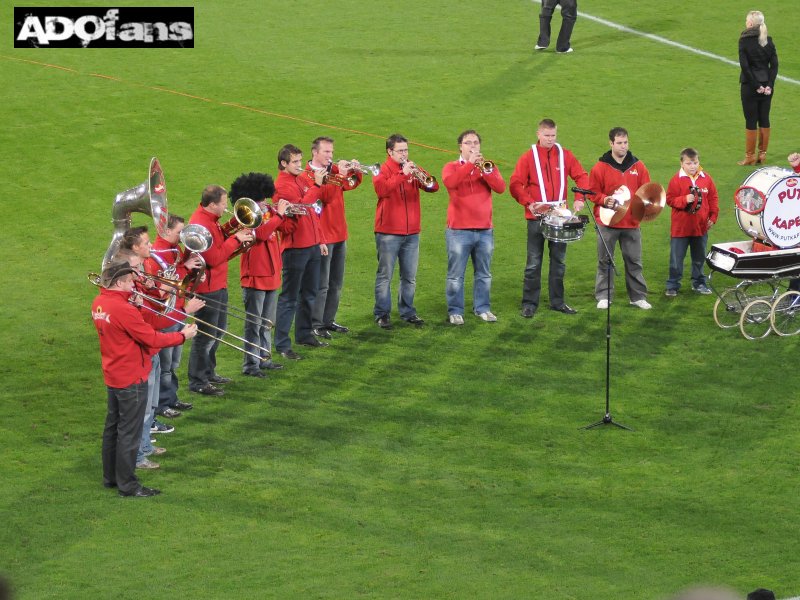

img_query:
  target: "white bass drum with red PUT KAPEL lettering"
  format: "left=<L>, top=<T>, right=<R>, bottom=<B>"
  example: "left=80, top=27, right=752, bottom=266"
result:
left=733, top=167, right=800, bottom=248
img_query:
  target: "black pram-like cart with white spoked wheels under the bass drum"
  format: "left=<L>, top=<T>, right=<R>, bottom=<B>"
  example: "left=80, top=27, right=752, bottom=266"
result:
left=706, top=240, right=800, bottom=340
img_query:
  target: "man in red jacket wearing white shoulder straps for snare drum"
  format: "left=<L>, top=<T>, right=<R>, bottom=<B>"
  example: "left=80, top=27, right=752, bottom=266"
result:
left=509, top=119, right=589, bottom=319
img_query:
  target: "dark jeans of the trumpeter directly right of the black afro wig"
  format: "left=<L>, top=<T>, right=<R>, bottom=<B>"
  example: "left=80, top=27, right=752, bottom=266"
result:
left=275, top=246, right=320, bottom=352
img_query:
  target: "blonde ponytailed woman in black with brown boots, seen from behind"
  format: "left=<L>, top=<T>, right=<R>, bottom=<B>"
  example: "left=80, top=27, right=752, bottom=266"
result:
left=739, top=10, right=778, bottom=165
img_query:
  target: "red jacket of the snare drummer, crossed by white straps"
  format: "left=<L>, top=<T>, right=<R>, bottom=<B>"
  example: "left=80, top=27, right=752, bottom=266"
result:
left=509, top=144, right=589, bottom=220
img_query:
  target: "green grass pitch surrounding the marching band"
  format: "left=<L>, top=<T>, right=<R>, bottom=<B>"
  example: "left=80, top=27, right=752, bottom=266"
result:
left=0, top=0, right=800, bottom=600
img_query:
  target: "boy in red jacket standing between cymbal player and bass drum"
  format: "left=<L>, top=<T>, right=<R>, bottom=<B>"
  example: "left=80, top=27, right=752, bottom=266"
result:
left=665, top=148, right=719, bottom=298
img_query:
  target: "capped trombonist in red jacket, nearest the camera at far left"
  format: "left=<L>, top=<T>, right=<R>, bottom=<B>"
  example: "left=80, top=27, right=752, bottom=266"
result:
left=92, top=261, right=197, bottom=497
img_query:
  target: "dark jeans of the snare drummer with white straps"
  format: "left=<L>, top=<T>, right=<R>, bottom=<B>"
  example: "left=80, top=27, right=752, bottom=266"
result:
left=522, top=219, right=567, bottom=310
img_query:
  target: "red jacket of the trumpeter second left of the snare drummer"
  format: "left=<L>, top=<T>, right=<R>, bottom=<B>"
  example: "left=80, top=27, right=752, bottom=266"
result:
left=372, top=158, right=439, bottom=235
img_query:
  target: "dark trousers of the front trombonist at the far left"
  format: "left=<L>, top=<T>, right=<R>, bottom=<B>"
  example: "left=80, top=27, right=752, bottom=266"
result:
left=103, top=383, right=147, bottom=493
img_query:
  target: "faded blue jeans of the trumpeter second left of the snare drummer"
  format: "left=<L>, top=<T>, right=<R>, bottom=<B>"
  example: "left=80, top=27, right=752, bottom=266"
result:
left=373, top=233, right=419, bottom=319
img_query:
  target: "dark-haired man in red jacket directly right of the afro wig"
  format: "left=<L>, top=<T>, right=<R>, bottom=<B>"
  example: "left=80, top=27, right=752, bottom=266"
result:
left=275, top=144, right=328, bottom=360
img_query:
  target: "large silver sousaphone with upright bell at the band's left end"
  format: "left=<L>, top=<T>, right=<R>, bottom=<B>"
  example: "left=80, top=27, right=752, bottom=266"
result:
left=102, top=156, right=168, bottom=269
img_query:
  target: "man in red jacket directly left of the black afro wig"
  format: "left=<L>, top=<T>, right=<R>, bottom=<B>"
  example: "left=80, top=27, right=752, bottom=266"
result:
left=189, top=185, right=253, bottom=396
